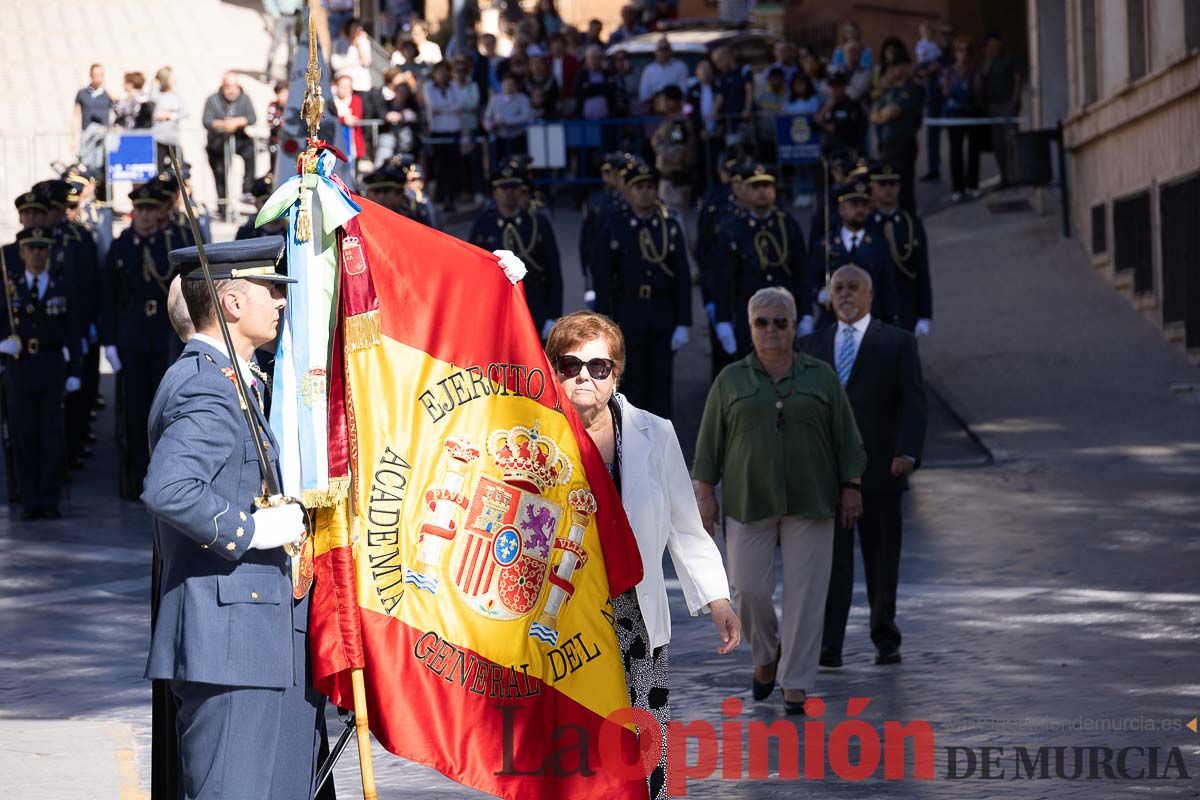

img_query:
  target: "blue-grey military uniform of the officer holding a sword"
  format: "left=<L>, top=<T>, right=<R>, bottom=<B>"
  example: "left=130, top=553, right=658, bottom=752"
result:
left=142, top=341, right=325, bottom=800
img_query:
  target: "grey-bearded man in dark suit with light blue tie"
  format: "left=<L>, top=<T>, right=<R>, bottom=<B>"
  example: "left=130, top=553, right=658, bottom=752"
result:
left=799, top=264, right=925, bottom=667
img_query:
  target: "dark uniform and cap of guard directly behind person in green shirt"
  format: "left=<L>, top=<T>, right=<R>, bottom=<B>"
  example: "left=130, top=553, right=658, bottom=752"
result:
left=713, top=164, right=808, bottom=359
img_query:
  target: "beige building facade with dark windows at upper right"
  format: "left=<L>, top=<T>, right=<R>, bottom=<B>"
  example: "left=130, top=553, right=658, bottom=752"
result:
left=1027, top=0, right=1200, bottom=352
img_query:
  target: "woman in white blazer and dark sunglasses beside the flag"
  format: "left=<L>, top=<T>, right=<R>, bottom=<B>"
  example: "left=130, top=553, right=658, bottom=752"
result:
left=546, top=311, right=742, bottom=800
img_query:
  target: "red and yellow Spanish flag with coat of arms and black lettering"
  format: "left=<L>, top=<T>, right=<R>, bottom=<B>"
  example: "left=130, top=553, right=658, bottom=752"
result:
left=310, top=198, right=647, bottom=800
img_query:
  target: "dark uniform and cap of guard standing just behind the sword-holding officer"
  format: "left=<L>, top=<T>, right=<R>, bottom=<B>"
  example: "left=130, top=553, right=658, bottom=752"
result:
left=101, top=186, right=178, bottom=498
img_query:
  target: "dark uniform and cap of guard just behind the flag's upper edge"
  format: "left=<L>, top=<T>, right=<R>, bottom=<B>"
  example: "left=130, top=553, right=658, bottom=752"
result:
left=467, top=164, right=563, bottom=336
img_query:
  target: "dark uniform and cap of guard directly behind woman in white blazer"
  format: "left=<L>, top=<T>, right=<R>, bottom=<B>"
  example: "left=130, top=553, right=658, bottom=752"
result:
left=592, top=159, right=691, bottom=419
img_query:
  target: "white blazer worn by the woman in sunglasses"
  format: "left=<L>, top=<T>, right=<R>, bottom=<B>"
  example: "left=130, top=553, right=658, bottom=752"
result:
left=618, top=396, right=730, bottom=649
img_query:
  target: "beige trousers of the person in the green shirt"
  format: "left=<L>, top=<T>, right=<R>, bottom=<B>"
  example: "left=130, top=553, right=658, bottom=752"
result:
left=725, top=516, right=833, bottom=691
